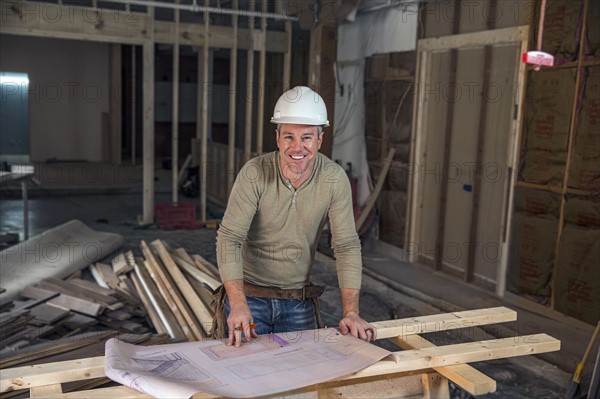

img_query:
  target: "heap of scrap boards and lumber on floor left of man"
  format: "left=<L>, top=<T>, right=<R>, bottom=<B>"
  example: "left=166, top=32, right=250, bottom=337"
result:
left=0, top=240, right=221, bottom=369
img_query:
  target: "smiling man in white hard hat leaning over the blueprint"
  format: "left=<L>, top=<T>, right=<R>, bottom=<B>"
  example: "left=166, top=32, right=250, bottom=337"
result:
left=217, top=86, right=376, bottom=346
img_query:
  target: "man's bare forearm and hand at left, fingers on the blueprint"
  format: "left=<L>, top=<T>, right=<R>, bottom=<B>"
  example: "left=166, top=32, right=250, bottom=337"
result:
left=223, top=280, right=258, bottom=347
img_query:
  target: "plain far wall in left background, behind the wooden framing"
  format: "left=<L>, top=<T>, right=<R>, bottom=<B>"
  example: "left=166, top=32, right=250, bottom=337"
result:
left=0, top=34, right=110, bottom=162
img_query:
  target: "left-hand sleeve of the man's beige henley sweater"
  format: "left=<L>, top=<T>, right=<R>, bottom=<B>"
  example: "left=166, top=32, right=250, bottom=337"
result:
left=216, top=160, right=261, bottom=282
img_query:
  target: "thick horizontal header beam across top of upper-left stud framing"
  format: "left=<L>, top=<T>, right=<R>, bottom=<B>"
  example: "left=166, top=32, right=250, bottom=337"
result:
left=0, top=1, right=287, bottom=53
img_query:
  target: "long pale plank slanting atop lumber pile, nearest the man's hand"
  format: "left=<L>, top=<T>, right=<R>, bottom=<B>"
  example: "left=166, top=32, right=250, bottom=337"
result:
left=152, top=240, right=213, bottom=339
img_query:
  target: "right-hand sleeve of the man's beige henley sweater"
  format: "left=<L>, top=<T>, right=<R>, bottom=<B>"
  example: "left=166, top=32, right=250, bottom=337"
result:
left=329, top=167, right=362, bottom=289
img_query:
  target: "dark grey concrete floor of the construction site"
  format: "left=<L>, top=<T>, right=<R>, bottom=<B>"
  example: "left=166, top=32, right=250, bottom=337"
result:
left=0, top=193, right=595, bottom=398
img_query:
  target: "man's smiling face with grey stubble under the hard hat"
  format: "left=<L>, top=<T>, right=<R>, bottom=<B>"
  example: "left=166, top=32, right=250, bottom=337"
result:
left=277, top=125, right=323, bottom=180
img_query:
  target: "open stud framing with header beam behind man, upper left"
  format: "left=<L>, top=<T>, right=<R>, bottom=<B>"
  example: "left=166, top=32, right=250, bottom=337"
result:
left=0, top=0, right=292, bottom=224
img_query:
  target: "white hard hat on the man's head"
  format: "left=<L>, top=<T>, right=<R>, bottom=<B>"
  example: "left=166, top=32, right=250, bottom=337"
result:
left=271, top=86, right=329, bottom=127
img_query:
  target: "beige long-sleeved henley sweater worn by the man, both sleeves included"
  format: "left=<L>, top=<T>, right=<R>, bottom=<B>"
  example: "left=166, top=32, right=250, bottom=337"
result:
left=217, top=152, right=362, bottom=289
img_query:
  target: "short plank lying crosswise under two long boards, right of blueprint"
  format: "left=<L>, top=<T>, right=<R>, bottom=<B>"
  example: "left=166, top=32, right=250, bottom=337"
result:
left=390, top=335, right=496, bottom=396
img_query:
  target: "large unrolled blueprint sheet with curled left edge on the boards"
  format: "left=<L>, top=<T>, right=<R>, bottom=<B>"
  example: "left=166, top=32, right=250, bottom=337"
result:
left=105, top=328, right=390, bottom=398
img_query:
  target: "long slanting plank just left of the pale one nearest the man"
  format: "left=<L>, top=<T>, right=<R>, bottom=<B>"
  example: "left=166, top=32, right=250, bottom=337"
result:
left=141, top=241, right=203, bottom=341
